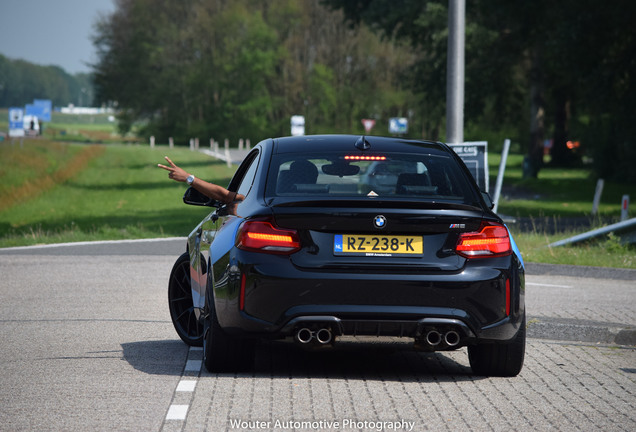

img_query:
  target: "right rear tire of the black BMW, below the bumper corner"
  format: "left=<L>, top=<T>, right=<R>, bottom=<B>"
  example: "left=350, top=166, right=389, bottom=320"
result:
left=468, top=314, right=526, bottom=377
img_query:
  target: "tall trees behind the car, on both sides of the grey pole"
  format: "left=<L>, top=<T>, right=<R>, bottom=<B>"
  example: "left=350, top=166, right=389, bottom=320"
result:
left=94, top=0, right=636, bottom=181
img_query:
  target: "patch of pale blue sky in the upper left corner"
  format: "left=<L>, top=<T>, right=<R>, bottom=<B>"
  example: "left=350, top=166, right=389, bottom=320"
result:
left=0, top=0, right=115, bottom=74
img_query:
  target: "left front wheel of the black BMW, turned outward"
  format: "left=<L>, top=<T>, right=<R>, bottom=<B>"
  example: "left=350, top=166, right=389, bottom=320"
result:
left=168, top=252, right=203, bottom=346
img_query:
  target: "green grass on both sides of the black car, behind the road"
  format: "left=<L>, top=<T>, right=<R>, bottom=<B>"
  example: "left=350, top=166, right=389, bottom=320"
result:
left=0, top=139, right=636, bottom=268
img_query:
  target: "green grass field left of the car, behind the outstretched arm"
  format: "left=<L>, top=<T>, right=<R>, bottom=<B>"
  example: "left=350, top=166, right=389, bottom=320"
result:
left=0, top=140, right=234, bottom=247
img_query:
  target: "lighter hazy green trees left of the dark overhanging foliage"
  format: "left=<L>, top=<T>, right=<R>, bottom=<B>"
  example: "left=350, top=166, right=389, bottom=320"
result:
left=94, top=0, right=413, bottom=142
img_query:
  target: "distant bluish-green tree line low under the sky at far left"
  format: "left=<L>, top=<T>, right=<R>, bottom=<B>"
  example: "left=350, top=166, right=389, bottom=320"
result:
left=0, top=54, right=93, bottom=108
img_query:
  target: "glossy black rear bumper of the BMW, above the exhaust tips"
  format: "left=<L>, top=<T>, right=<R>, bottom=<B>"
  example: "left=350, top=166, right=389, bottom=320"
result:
left=215, top=251, right=525, bottom=349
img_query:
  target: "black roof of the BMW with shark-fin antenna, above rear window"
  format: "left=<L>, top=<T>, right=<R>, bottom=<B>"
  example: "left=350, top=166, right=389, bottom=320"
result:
left=273, top=135, right=451, bottom=155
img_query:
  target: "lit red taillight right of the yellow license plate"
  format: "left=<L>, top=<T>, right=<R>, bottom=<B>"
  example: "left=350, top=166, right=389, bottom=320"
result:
left=455, top=222, right=512, bottom=258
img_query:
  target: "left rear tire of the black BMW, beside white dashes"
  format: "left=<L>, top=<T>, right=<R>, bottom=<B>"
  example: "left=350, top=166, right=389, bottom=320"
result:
left=203, top=294, right=255, bottom=373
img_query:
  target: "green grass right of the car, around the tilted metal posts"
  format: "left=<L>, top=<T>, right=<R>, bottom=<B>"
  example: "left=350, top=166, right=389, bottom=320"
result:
left=489, top=153, right=636, bottom=269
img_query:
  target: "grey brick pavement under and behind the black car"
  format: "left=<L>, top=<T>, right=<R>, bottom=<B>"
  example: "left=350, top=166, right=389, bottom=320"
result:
left=178, top=340, right=636, bottom=431
